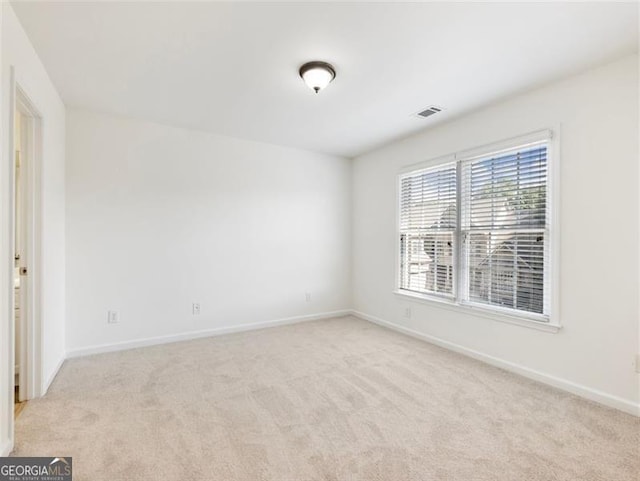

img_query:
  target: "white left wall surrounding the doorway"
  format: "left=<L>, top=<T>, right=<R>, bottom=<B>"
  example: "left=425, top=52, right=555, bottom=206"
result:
left=0, top=2, right=65, bottom=452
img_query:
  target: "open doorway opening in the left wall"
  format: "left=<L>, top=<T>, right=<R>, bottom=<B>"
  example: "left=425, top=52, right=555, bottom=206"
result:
left=12, top=85, right=41, bottom=416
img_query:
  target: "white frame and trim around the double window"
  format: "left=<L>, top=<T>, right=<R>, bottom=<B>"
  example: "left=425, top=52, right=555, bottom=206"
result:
left=393, top=126, right=562, bottom=332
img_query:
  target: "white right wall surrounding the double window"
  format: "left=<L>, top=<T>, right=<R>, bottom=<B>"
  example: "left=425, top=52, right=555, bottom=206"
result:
left=353, top=56, right=640, bottom=413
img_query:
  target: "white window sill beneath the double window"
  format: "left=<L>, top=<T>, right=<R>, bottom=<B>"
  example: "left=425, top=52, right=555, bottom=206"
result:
left=393, top=290, right=562, bottom=334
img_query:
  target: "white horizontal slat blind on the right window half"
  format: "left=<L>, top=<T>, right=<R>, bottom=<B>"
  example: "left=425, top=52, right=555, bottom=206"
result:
left=461, top=142, right=549, bottom=314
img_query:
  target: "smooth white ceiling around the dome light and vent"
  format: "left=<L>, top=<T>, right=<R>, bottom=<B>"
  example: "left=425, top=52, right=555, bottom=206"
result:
left=13, top=2, right=638, bottom=157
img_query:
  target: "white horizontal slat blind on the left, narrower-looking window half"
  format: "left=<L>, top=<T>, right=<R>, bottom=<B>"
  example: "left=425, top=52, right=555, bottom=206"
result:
left=400, top=163, right=457, bottom=297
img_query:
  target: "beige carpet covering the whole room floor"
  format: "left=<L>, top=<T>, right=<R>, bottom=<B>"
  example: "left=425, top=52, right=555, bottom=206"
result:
left=14, top=317, right=640, bottom=481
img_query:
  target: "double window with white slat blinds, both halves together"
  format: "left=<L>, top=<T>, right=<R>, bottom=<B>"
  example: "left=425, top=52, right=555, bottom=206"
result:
left=398, top=132, right=550, bottom=321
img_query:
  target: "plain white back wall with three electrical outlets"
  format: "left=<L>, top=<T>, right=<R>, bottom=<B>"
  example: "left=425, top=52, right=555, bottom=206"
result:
left=67, top=110, right=351, bottom=355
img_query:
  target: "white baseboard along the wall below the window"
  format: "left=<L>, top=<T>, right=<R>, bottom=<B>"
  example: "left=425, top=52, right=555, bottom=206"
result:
left=351, top=310, right=640, bottom=417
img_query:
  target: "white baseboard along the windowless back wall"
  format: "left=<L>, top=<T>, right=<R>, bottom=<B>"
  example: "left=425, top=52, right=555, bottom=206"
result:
left=67, top=309, right=352, bottom=359
